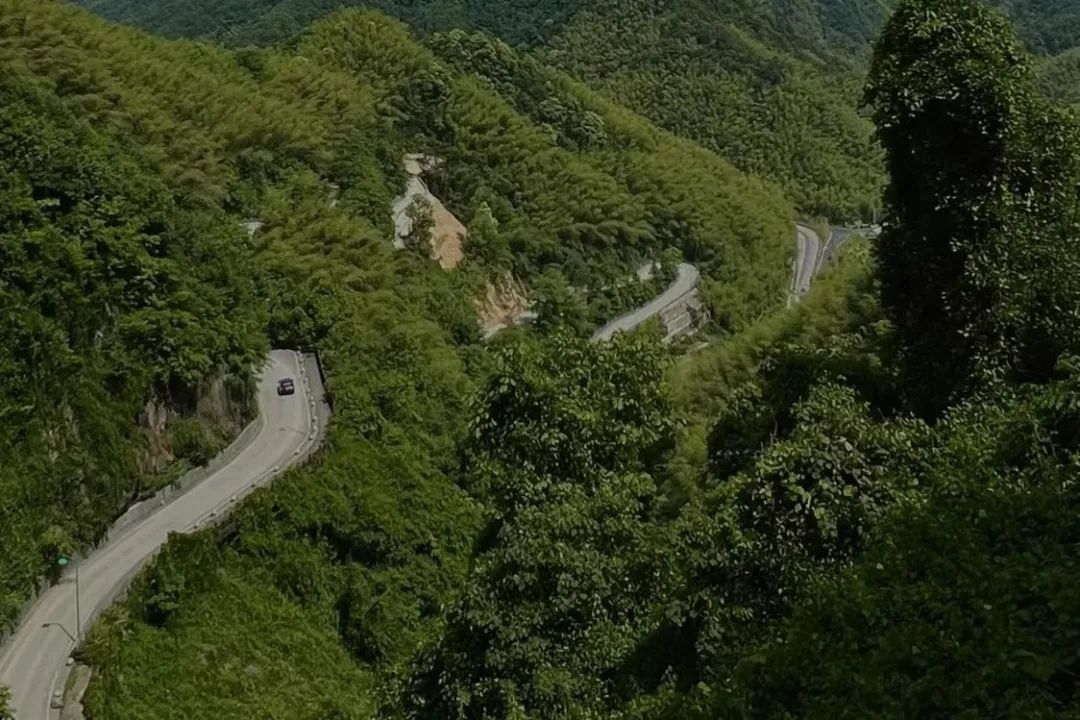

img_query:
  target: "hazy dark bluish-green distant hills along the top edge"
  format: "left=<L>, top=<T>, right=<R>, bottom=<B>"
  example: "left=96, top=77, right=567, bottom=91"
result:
left=75, top=0, right=1080, bottom=57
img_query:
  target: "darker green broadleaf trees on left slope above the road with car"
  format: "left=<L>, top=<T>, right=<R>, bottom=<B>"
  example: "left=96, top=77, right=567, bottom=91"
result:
left=0, top=8, right=266, bottom=625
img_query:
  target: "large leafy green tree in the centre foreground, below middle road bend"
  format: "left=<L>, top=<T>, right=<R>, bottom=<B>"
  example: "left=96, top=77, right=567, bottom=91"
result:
left=408, top=334, right=673, bottom=720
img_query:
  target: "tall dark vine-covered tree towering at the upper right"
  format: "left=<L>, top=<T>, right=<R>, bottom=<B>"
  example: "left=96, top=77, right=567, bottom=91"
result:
left=866, top=0, right=1080, bottom=413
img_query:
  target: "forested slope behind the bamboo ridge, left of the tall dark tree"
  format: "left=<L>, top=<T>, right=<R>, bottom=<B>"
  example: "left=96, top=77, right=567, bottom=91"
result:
left=538, top=0, right=880, bottom=219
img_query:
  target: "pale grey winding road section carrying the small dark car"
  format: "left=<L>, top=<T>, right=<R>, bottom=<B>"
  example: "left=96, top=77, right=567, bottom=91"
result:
left=0, top=351, right=321, bottom=720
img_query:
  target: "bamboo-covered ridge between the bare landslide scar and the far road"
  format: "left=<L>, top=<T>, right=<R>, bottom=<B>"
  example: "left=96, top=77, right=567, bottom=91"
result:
left=287, top=9, right=791, bottom=328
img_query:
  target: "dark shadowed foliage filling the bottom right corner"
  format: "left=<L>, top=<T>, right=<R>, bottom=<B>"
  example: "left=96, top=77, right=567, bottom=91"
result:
left=738, top=414, right=1080, bottom=718
